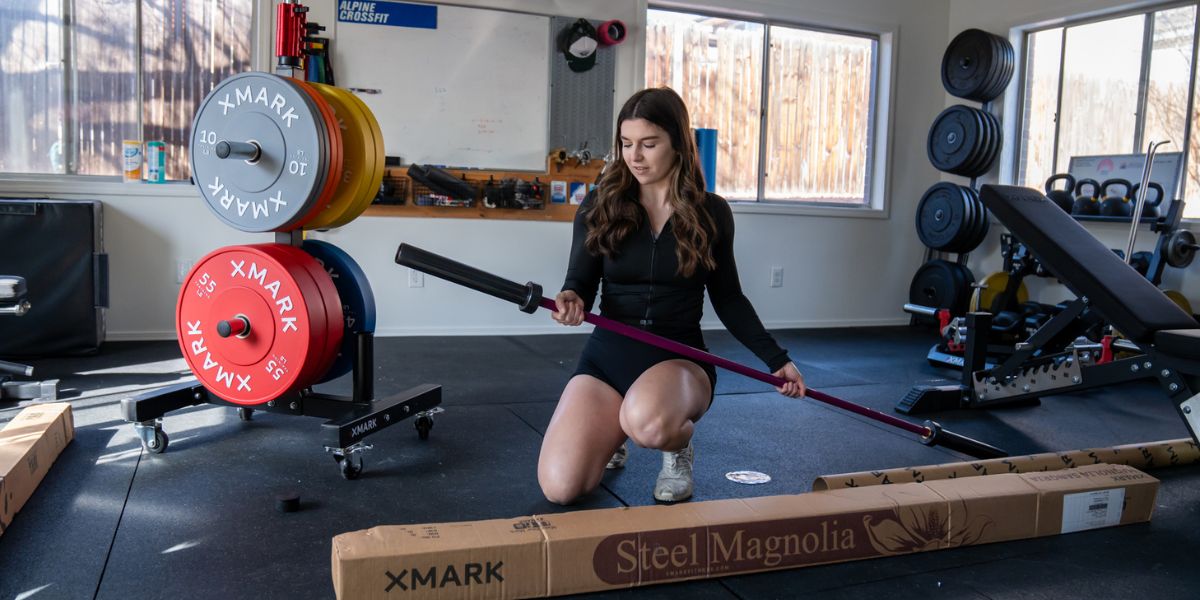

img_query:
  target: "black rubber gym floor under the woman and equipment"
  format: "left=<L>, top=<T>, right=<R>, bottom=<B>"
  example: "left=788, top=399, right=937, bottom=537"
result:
left=0, top=328, right=1200, bottom=600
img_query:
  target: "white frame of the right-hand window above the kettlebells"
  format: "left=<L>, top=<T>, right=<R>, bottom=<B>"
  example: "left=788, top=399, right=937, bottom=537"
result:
left=1012, top=0, right=1200, bottom=206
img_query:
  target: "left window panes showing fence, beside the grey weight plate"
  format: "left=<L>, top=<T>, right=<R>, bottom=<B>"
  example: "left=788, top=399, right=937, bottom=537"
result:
left=0, top=0, right=253, bottom=179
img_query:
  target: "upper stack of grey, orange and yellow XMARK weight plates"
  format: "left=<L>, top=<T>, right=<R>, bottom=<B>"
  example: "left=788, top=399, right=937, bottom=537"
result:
left=191, top=73, right=384, bottom=233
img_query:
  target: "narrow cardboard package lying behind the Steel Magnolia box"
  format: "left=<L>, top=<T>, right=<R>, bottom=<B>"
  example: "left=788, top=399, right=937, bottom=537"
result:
left=812, top=438, right=1200, bottom=491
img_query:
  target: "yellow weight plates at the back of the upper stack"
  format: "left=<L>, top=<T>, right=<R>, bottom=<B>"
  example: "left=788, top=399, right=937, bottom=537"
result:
left=305, top=83, right=373, bottom=229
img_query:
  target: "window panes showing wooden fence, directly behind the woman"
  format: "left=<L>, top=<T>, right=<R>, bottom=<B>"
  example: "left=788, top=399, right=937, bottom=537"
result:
left=646, top=10, right=878, bottom=206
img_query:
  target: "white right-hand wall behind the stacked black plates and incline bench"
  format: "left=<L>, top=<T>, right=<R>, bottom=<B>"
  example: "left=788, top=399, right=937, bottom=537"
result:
left=942, top=0, right=1200, bottom=304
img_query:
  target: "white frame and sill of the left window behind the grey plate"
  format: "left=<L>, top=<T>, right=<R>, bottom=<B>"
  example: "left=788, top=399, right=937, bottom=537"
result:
left=0, top=0, right=265, bottom=188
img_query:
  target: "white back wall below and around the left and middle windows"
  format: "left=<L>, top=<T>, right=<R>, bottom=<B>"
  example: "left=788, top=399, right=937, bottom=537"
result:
left=0, top=0, right=955, bottom=340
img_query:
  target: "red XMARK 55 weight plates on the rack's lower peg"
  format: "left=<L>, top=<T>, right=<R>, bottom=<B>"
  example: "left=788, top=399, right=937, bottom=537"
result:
left=175, top=246, right=326, bottom=406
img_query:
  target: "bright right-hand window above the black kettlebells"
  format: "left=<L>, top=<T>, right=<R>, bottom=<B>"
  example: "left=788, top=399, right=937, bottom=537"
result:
left=1018, top=4, right=1200, bottom=218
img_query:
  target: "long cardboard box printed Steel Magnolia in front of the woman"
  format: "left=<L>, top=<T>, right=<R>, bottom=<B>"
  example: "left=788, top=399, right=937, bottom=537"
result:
left=332, top=464, right=1158, bottom=600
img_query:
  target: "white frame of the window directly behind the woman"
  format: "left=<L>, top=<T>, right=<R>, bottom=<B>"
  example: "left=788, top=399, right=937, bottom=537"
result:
left=642, top=2, right=896, bottom=218
